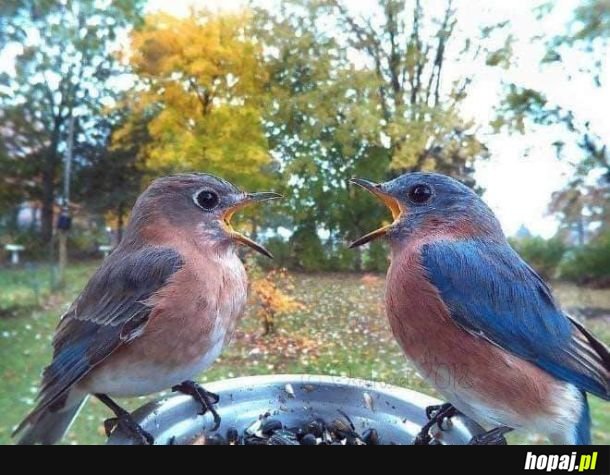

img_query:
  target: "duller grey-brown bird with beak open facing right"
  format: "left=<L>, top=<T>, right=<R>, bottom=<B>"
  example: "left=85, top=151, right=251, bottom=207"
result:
left=13, top=173, right=281, bottom=444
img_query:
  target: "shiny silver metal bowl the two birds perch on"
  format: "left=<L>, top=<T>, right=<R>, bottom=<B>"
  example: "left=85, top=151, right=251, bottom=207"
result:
left=108, top=374, right=484, bottom=445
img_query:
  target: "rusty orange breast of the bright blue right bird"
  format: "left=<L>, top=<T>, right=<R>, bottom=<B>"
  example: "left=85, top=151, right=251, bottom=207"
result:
left=385, top=246, right=557, bottom=417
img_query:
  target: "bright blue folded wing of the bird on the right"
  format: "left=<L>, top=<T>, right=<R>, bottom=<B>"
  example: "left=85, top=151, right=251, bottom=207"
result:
left=422, top=240, right=610, bottom=399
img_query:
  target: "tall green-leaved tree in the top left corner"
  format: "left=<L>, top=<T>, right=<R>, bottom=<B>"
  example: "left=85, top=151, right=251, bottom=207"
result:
left=0, top=0, right=142, bottom=241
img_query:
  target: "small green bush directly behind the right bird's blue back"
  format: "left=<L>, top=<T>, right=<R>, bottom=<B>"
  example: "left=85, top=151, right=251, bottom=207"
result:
left=509, top=236, right=567, bottom=279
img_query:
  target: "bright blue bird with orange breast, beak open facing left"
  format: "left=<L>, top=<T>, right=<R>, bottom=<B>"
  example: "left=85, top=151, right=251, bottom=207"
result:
left=350, top=172, right=610, bottom=445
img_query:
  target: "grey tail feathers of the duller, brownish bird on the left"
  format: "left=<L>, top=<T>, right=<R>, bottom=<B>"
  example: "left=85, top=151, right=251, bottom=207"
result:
left=13, top=390, right=87, bottom=445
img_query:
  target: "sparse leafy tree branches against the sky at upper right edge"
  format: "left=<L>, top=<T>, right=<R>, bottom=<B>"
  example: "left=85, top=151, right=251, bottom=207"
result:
left=494, top=0, right=610, bottom=245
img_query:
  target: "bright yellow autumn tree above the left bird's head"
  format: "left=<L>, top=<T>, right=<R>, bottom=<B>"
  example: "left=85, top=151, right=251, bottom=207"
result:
left=115, top=11, right=272, bottom=192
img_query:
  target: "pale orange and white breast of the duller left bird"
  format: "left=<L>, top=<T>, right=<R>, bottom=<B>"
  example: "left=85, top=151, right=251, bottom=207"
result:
left=86, top=245, right=248, bottom=396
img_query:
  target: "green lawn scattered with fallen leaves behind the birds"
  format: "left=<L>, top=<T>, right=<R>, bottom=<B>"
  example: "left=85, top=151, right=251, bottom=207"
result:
left=0, top=263, right=610, bottom=444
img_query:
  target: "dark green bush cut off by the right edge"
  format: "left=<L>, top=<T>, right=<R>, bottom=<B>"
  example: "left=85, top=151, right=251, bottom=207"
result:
left=560, top=231, right=610, bottom=287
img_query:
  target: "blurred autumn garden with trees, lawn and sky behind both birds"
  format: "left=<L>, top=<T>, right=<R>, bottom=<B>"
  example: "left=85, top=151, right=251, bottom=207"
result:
left=0, top=0, right=610, bottom=443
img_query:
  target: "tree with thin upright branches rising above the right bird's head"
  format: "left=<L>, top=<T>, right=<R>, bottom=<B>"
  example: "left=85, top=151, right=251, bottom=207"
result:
left=324, top=0, right=486, bottom=182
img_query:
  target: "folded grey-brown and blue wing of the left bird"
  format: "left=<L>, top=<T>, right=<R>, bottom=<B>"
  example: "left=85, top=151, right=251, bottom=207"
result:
left=38, top=247, right=183, bottom=408
